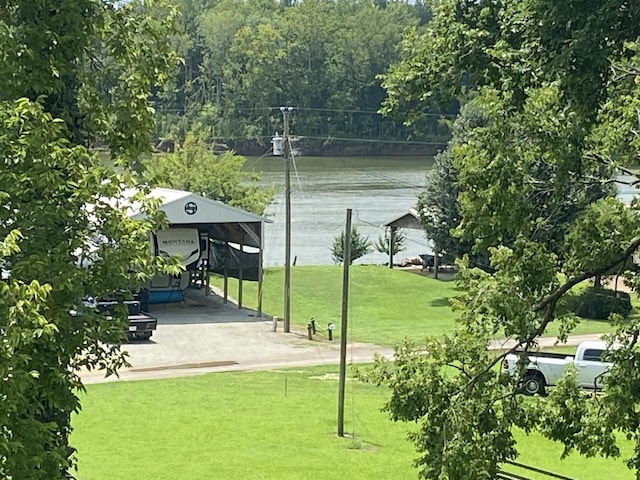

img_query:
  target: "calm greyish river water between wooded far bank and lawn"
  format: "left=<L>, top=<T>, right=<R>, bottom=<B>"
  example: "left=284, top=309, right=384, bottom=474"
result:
left=246, top=156, right=432, bottom=267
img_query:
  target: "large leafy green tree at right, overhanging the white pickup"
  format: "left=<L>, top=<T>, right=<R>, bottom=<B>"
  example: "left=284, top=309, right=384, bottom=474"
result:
left=374, top=0, right=640, bottom=480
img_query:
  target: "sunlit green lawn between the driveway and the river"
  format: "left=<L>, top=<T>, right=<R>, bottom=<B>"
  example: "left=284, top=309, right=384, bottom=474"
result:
left=211, top=265, right=620, bottom=345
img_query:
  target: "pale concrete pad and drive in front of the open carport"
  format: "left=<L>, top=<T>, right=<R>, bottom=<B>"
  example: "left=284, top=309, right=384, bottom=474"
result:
left=82, top=290, right=393, bottom=383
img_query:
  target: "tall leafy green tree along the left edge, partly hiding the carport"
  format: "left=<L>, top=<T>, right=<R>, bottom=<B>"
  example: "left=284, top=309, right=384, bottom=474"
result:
left=0, top=0, right=175, bottom=480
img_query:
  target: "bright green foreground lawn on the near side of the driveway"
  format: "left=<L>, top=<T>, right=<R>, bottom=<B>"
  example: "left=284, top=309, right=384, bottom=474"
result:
left=71, top=366, right=633, bottom=480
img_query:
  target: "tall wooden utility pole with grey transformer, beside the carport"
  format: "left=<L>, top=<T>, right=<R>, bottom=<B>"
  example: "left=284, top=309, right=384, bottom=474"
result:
left=280, top=107, right=293, bottom=333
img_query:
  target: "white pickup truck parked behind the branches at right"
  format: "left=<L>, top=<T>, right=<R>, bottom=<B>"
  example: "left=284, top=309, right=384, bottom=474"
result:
left=502, top=341, right=611, bottom=395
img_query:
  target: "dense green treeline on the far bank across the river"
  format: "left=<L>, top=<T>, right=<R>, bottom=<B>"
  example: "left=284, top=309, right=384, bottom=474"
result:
left=155, top=0, right=456, bottom=154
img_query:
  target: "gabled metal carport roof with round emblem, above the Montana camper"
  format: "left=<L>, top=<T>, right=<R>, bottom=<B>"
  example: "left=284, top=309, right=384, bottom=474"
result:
left=133, top=188, right=271, bottom=248
